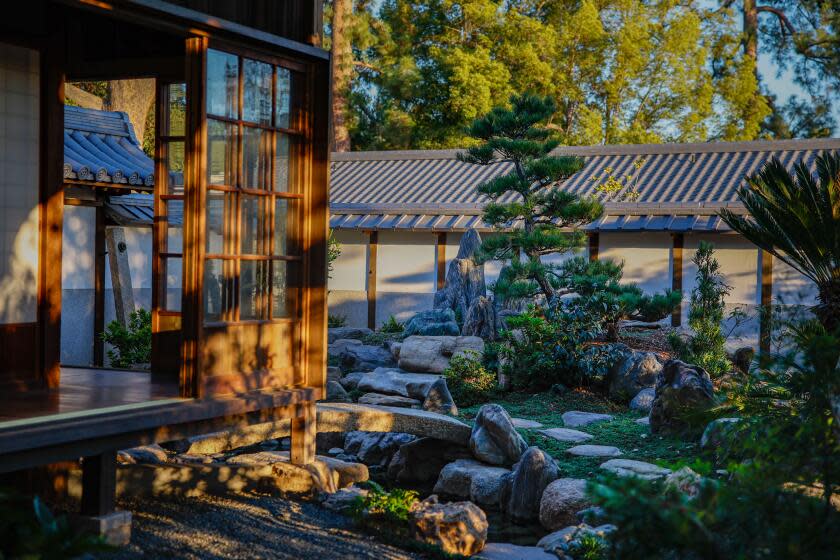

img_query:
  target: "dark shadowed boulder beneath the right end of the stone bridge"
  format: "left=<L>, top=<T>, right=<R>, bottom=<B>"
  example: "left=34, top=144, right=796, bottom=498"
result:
left=388, top=438, right=472, bottom=484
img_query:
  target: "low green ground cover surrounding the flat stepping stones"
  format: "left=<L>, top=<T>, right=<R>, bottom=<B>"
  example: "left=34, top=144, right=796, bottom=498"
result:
left=461, top=390, right=700, bottom=478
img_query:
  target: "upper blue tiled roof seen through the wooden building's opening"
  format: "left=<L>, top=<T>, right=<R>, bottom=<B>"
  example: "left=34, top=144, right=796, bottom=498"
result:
left=64, top=106, right=154, bottom=187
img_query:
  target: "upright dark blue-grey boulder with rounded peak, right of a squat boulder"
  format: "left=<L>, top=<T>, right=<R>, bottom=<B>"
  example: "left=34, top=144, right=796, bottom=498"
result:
left=499, top=447, right=560, bottom=522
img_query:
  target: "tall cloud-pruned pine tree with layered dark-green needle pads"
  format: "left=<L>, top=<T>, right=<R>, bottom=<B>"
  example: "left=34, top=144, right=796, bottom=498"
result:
left=459, top=94, right=603, bottom=300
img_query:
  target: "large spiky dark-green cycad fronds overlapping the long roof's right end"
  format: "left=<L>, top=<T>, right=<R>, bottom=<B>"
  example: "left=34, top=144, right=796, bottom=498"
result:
left=720, top=153, right=840, bottom=333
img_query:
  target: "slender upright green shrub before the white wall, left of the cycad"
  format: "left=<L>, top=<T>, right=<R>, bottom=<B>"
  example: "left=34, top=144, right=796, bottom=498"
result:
left=668, top=241, right=732, bottom=377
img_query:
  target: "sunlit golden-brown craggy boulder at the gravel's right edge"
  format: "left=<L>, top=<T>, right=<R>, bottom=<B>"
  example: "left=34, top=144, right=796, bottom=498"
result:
left=409, top=495, right=489, bottom=556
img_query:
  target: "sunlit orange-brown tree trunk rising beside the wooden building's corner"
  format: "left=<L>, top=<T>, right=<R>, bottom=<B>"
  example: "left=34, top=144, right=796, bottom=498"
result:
left=331, top=0, right=353, bottom=152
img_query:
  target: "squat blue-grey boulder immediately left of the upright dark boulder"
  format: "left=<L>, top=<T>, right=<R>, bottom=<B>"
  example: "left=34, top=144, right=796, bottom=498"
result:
left=434, top=459, right=510, bottom=506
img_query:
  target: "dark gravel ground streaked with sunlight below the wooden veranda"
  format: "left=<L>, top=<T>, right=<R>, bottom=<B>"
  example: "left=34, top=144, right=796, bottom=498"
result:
left=103, top=495, right=422, bottom=560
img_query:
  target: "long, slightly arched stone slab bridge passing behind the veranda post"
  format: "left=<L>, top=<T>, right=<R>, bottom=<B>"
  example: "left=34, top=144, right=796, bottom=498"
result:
left=183, top=403, right=471, bottom=455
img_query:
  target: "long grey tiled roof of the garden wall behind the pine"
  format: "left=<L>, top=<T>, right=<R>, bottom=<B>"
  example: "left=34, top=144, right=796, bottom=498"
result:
left=330, top=139, right=840, bottom=231
